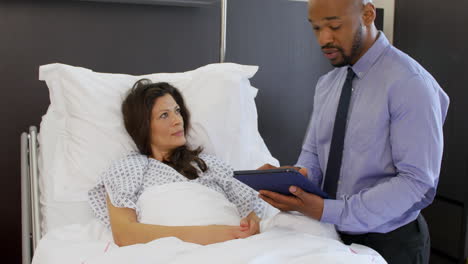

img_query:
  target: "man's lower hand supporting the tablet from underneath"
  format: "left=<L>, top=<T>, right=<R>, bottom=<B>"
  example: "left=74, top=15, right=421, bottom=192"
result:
left=259, top=186, right=324, bottom=220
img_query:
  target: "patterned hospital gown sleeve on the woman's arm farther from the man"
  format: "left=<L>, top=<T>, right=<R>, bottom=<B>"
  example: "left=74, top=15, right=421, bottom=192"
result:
left=88, top=153, right=148, bottom=227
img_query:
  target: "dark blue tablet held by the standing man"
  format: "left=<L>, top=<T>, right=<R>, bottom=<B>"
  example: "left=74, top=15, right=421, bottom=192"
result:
left=234, top=168, right=328, bottom=198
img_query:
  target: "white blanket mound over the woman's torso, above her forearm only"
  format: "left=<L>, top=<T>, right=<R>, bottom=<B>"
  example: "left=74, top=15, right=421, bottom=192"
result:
left=137, top=182, right=241, bottom=226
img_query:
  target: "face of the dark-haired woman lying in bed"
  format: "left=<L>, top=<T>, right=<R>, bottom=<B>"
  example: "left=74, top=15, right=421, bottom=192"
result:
left=151, top=94, right=186, bottom=156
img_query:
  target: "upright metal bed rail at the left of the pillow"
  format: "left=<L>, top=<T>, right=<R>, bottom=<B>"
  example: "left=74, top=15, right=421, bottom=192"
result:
left=21, top=126, right=41, bottom=264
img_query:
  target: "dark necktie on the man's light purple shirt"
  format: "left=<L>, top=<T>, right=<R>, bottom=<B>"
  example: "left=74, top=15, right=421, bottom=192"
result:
left=323, top=67, right=356, bottom=199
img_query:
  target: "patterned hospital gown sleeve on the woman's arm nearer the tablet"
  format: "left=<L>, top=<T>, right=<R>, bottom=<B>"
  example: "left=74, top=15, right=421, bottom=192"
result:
left=204, top=155, right=267, bottom=218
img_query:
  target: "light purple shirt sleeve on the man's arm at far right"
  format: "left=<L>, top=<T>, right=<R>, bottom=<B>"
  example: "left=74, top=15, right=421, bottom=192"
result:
left=321, top=75, right=448, bottom=232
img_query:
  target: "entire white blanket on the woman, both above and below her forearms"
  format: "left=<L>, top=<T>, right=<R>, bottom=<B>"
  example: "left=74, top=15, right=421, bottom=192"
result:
left=33, top=184, right=386, bottom=264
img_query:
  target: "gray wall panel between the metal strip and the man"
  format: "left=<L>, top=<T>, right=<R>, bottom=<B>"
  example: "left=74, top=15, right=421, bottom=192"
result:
left=226, top=0, right=331, bottom=165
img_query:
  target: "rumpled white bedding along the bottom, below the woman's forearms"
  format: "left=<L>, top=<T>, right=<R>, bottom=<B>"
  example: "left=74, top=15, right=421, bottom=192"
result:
left=33, top=213, right=386, bottom=264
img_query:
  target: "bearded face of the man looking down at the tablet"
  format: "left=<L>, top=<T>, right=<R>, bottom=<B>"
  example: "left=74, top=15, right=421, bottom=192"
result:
left=309, top=0, right=363, bottom=67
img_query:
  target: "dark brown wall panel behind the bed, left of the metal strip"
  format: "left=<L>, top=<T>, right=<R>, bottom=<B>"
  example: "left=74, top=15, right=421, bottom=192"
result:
left=0, top=0, right=220, bottom=263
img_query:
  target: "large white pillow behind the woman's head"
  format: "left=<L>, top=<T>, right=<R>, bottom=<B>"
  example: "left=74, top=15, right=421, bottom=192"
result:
left=39, top=63, right=278, bottom=232
